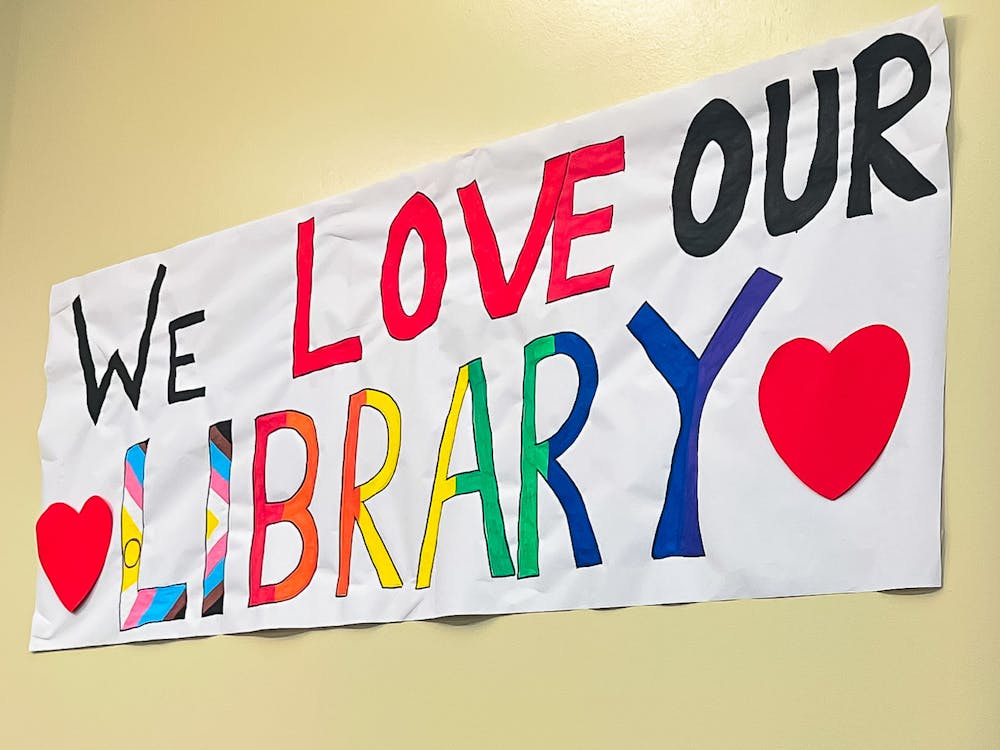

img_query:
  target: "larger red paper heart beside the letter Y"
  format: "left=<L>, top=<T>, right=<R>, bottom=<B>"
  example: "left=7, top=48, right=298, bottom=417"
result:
left=758, top=325, right=910, bottom=500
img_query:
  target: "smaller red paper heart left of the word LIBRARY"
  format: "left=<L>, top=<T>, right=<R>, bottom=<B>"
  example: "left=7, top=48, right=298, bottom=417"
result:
left=35, top=495, right=112, bottom=612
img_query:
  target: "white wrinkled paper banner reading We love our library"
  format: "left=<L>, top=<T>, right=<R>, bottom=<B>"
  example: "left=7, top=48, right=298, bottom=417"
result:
left=30, top=11, right=950, bottom=650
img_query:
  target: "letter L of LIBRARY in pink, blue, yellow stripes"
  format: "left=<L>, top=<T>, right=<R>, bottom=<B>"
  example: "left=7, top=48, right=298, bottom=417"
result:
left=119, top=440, right=187, bottom=631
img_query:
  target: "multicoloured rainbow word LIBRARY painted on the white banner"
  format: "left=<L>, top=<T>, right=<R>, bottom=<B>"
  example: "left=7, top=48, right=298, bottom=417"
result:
left=78, top=269, right=781, bottom=630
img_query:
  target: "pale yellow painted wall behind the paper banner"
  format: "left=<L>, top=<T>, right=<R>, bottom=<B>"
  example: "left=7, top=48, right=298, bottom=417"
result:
left=0, top=0, right=1000, bottom=748
